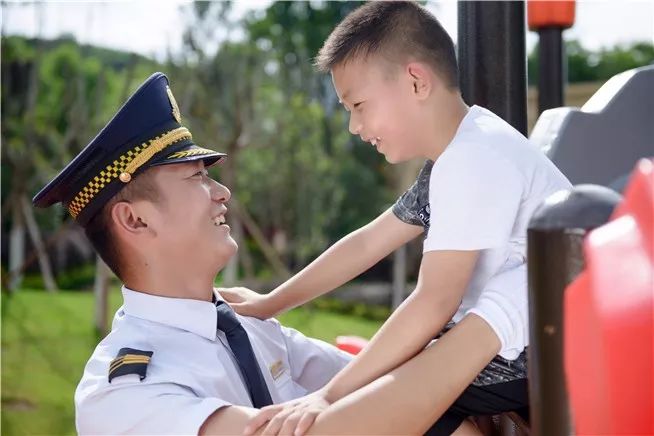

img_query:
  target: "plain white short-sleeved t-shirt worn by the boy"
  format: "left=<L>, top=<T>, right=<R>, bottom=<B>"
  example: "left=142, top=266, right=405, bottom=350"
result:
left=423, top=106, right=571, bottom=360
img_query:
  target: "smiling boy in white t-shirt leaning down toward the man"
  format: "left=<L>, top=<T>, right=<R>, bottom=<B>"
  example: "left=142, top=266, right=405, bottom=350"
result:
left=223, top=2, right=570, bottom=434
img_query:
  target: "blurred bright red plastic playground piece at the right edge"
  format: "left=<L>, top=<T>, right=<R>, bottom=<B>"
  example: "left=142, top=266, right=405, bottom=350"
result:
left=564, top=160, right=654, bottom=434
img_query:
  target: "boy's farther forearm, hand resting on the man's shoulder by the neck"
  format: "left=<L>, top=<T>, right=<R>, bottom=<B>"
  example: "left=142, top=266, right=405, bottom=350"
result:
left=220, top=209, right=423, bottom=318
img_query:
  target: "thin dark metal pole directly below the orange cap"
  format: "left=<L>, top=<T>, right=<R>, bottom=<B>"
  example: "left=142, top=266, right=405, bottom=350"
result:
left=538, top=26, right=565, bottom=113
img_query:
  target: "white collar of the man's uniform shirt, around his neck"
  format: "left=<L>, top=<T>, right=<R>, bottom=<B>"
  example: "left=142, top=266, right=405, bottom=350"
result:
left=122, top=286, right=220, bottom=341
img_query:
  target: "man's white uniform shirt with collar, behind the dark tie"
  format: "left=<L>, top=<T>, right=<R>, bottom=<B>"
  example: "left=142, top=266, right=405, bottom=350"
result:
left=75, top=287, right=351, bottom=434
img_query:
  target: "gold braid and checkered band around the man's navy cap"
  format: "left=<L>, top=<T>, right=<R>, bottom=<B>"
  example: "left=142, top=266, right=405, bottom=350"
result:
left=68, top=127, right=192, bottom=218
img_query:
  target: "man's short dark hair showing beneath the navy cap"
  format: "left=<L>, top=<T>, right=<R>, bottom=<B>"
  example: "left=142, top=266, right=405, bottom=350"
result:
left=84, top=170, right=161, bottom=281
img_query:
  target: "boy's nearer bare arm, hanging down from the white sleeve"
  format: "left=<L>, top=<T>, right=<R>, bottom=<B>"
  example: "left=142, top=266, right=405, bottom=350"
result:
left=246, top=251, right=480, bottom=432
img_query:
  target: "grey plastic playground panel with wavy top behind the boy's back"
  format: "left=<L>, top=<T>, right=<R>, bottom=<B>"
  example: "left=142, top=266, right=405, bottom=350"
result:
left=530, top=65, right=654, bottom=192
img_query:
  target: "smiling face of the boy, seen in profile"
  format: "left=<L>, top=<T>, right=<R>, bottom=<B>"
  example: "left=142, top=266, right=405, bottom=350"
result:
left=332, top=56, right=420, bottom=163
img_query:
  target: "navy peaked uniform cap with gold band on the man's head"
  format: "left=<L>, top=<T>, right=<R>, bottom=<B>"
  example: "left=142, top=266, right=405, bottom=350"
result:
left=33, top=72, right=225, bottom=225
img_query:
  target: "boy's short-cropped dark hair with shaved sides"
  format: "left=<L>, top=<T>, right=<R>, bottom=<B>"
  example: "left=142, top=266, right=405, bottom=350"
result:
left=315, top=1, right=458, bottom=88
